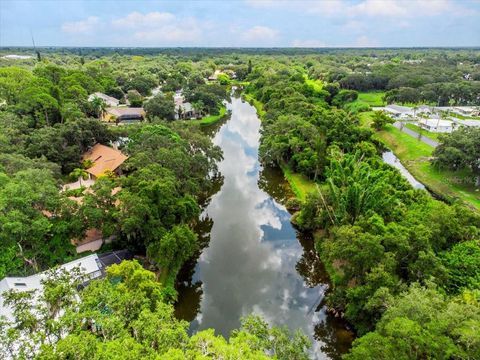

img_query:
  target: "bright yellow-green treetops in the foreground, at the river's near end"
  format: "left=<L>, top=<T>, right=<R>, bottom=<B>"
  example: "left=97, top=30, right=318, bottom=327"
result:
left=0, top=261, right=309, bottom=360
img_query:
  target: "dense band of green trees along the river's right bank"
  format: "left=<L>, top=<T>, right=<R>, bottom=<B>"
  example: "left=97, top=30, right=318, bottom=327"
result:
left=247, top=49, right=480, bottom=359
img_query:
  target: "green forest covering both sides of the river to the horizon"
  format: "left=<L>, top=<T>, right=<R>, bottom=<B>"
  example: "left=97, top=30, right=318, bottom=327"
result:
left=0, top=48, right=480, bottom=360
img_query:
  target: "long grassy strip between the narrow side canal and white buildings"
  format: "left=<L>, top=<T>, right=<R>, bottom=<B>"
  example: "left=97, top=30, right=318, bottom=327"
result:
left=375, top=125, right=480, bottom=210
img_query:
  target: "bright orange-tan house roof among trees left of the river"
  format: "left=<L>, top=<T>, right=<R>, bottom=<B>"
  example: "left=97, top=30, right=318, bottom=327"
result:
left=83, top=144, right=128, bottom=177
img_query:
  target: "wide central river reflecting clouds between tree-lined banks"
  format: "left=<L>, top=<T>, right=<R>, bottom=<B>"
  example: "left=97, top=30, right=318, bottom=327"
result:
left=176, top=97, right=353, bottom=359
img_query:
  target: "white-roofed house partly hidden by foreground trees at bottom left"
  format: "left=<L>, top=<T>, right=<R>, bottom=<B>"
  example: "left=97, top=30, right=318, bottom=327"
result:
left=0, top=250, right=132, bottom=360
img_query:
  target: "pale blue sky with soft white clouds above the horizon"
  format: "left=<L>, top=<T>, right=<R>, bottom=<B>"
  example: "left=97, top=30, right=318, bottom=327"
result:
left=0, top=0, right=480, bottom=47
